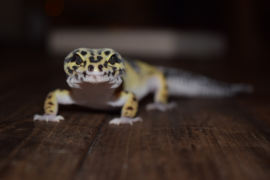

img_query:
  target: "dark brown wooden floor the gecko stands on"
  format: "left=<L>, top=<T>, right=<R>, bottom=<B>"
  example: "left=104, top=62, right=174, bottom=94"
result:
left=0, top=55, right=270, bottom=180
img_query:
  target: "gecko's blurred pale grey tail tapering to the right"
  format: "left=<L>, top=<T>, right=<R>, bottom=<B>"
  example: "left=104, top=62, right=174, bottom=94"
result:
left=158, top=67, right=254, bottom=97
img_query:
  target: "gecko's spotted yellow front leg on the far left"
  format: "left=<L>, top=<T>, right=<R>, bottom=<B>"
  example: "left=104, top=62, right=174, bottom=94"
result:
left=34, top=89, right=73, bottom=122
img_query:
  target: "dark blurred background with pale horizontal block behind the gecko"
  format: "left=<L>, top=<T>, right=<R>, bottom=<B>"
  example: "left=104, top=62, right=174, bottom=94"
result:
left=0, top=0, right=270, bottom=63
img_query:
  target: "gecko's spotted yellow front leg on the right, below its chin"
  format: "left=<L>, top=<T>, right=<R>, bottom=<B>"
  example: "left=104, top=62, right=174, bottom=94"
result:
left=109, top=91, right=142, bottom=125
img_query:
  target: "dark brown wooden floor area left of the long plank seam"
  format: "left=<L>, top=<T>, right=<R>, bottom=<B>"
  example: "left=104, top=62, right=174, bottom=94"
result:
left=0, top=58, right=105, bottom=180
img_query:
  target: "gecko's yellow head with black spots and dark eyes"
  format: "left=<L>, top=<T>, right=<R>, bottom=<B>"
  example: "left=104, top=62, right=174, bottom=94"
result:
left=64, top=48, right=125, bottom=83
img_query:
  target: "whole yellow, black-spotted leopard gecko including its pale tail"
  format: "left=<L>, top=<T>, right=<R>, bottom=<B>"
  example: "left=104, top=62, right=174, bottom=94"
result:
left=34, top=48, right=251, bottom=125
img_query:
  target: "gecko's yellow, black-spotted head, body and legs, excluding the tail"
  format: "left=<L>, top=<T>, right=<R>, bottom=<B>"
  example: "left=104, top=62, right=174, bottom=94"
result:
left=34, top=48, right=168, bottom=124
